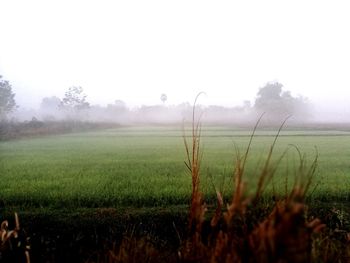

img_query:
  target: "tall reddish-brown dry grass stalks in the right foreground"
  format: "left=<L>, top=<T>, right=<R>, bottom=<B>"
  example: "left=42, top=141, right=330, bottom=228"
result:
left=180, top=111, right=324, bottom=262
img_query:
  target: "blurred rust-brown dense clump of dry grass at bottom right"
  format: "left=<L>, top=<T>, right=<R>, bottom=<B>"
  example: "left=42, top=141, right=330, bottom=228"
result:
left=249, top=186, right=325, bottom=262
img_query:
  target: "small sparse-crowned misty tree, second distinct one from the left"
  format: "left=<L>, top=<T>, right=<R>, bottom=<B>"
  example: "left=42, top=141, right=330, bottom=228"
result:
left=60, top=86, right=90, bottom=118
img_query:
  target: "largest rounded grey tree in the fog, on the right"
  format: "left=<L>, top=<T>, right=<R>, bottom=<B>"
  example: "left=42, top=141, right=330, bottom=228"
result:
left=254, top=82, right=310, bottom=121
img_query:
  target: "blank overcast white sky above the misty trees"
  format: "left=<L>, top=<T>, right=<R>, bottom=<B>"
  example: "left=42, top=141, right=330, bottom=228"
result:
left=0, top=0, right=350, bottom=115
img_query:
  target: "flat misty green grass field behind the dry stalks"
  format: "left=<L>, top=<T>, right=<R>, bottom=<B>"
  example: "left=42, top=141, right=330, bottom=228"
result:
left=0, top=127, right=350, bottom=208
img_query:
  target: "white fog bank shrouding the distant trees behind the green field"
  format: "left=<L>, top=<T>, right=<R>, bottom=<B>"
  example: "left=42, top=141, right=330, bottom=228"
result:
left=7, top=81, right=350, bottom=126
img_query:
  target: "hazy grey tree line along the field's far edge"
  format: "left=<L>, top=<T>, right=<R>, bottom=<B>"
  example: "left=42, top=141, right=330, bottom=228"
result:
left=0, top=76, right=311, bottom=122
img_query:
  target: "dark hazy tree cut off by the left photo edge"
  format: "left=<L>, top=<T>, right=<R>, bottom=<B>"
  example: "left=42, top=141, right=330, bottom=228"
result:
left=0, top=75, right=17, bottom=120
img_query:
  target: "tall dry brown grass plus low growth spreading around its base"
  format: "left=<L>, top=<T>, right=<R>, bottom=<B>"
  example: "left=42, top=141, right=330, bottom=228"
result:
left=111, top=98, right=350, bottom=263
